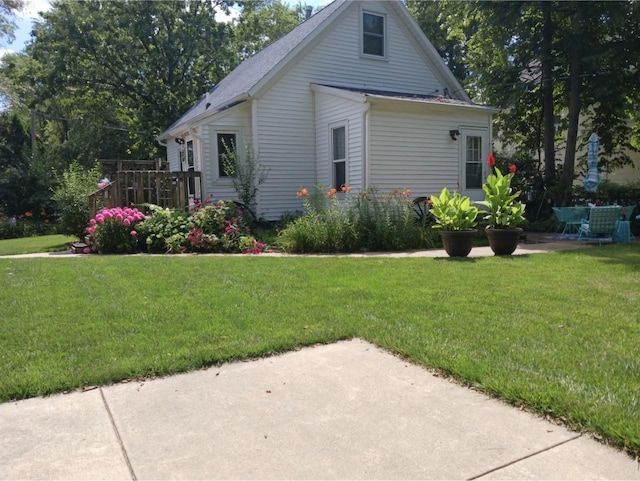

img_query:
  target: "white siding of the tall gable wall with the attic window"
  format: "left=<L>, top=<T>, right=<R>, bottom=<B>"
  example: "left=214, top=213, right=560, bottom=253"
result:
left=254, top=2, right=442, bottom=220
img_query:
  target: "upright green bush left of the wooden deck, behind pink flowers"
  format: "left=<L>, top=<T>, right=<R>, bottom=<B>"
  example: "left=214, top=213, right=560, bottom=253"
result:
left=53, top=162, right=100, bottom=239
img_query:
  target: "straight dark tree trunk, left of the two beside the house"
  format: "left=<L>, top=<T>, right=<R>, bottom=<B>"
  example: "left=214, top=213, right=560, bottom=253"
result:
left=542, top=1, right=556, bottom=187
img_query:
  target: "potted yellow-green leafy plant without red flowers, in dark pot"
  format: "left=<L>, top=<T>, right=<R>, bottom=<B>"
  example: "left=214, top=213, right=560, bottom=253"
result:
left=429, top=187, right=478, bottom=257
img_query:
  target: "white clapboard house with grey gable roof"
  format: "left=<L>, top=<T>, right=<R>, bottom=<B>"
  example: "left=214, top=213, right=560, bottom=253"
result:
left=159, top=1, right=497, bottom=220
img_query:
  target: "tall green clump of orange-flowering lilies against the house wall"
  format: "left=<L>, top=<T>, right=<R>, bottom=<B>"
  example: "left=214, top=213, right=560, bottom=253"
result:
left=277, top=186, right=434, bottom=253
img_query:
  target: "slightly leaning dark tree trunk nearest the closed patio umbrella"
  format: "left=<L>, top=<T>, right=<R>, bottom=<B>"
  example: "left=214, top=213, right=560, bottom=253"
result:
left=562, top=0, right=587, bottom=201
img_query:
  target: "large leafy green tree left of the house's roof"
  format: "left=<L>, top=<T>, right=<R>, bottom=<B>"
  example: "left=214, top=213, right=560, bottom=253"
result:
left=27, top=0, right=236, bottom=163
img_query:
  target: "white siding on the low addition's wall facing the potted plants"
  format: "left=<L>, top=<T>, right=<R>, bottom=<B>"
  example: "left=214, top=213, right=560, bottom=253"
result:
left=369, top=102, right=489, bottom=197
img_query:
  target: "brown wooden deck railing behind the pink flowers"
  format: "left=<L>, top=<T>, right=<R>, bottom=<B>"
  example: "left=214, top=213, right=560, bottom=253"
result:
left=89, top=170, right=201, bottom=218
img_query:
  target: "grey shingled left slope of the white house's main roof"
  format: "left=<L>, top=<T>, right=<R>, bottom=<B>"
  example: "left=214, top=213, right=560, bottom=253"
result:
left=160, top=0, right=348, bottom=138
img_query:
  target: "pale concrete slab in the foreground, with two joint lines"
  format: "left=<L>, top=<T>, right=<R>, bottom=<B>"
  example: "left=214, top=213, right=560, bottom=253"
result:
left=0, top=339, right=640, bottom=480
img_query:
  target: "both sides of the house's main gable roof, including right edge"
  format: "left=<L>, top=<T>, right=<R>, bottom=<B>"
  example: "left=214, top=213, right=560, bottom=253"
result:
left=158, top=0, right=471, bottom=140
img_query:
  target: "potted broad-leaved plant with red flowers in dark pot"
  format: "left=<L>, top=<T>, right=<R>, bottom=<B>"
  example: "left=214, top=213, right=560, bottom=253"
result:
left=478, top=154, right=524, bottom=255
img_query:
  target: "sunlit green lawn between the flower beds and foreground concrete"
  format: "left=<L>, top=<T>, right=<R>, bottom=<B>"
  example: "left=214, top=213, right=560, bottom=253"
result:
left=0, top=243, right=640, bottom=453
